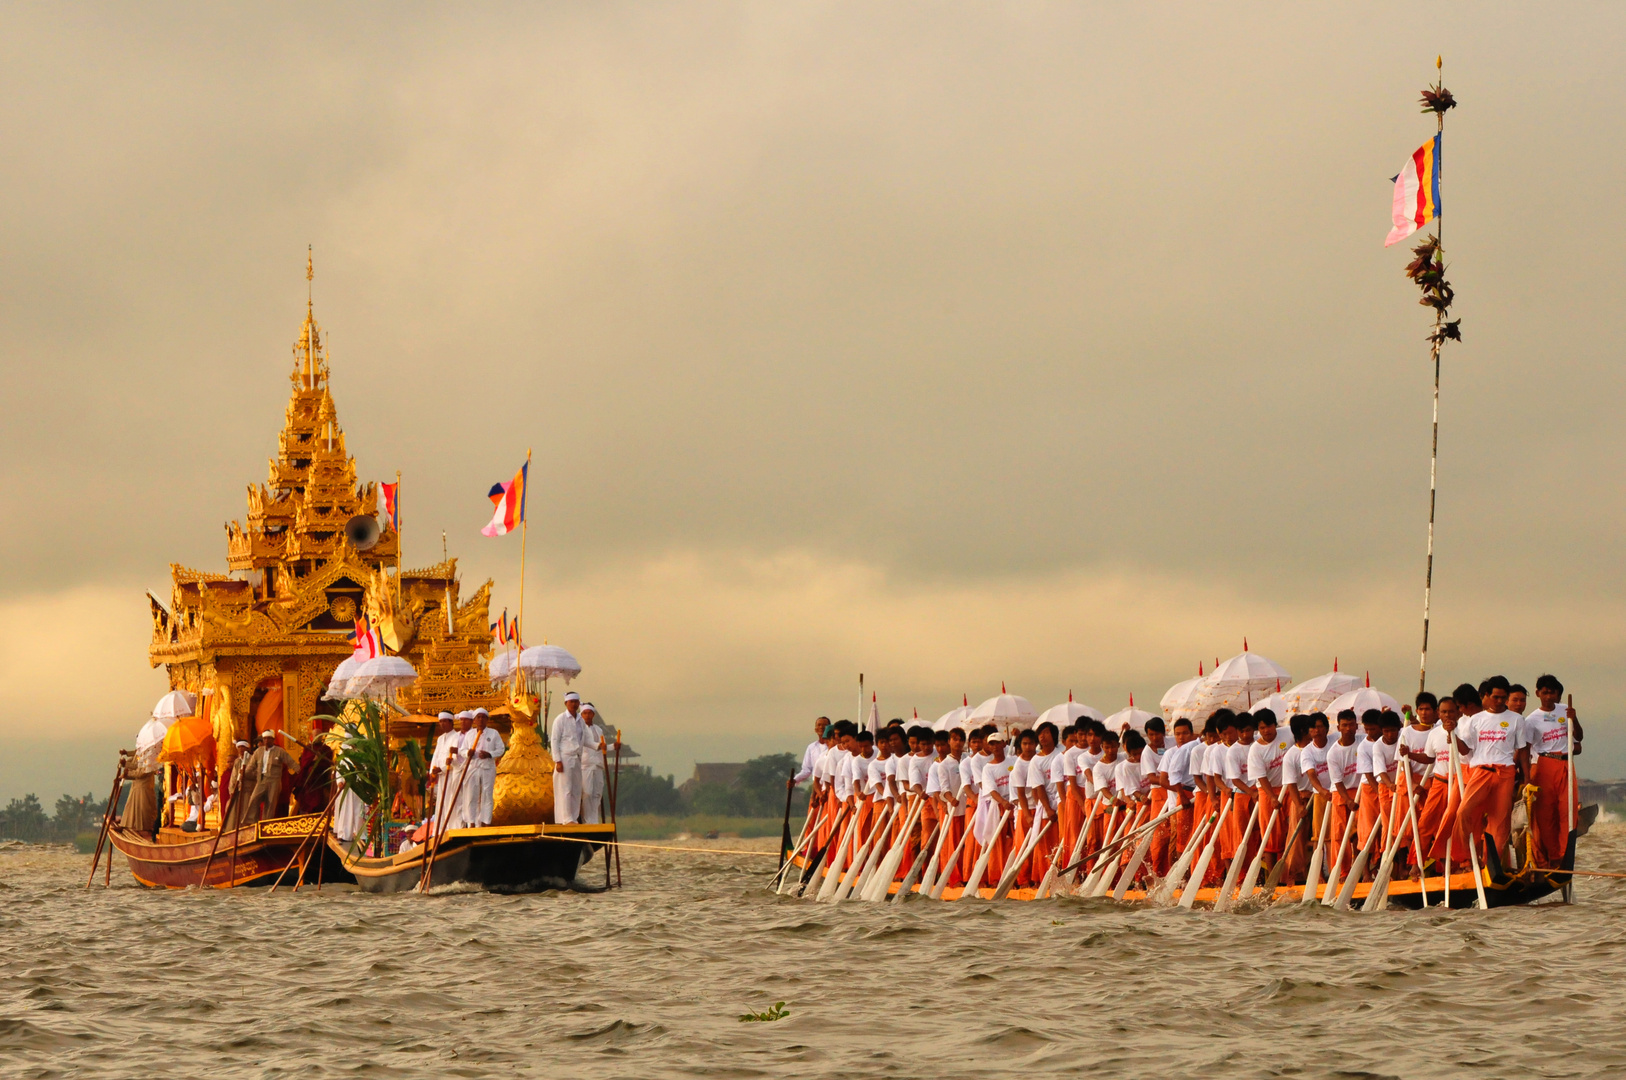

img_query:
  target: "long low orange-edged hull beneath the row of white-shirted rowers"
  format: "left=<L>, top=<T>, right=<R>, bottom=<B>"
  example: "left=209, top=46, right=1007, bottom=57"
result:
left=795, top=836, right=1576, bottom=909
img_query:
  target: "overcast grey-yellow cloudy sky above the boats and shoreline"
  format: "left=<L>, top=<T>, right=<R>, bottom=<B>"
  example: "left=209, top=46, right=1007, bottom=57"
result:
left=0, top=3, right=1626, bottom=802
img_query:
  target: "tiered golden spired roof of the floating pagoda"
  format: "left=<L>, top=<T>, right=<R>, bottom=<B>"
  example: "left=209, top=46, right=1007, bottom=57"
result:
left=148, top=263, right=502, bottom=764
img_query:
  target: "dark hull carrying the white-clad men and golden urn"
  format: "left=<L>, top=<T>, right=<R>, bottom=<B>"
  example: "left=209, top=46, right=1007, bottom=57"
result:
left=327, top=823, right=615, bottom=893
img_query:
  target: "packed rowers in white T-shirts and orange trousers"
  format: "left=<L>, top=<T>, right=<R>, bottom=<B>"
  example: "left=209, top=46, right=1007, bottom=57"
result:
left=790, top=675, right=1580, bottom=893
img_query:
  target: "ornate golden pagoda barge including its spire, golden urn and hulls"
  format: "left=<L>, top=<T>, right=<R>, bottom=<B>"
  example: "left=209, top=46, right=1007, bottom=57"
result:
left=93, top=267, right=615, bottom=891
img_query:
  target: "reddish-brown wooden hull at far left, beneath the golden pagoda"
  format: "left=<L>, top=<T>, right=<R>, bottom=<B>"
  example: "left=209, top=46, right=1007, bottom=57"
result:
left=109, top=813, right=351, bottom=888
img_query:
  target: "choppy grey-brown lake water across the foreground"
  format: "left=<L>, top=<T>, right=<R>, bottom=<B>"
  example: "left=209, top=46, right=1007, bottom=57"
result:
left=0, top=825, right=1626, bottom=1080
